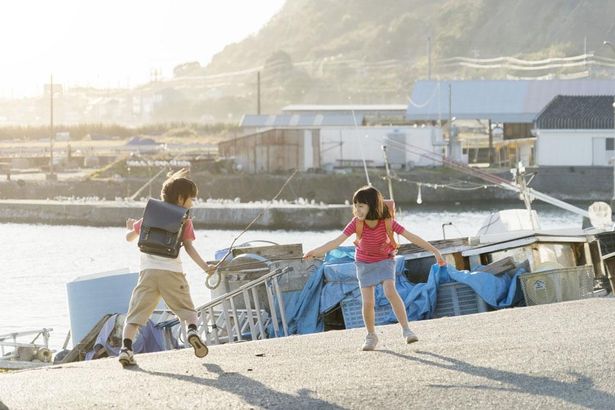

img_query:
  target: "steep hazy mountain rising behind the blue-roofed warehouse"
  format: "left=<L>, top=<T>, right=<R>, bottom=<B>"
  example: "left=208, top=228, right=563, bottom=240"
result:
left=184, top=0, right=615, bottom=112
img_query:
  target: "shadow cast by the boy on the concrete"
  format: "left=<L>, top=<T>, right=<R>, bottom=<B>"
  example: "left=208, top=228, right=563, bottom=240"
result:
left=127, top=363, right=343, bottom=409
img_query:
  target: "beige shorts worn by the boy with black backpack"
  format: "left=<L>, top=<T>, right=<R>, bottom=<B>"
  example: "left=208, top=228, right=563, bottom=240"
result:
left=126, top=269, right=196, bottom=326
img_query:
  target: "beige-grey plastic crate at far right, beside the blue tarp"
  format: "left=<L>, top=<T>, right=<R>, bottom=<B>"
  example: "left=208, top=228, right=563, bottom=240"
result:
left=519, top=265, right=594, bottom=306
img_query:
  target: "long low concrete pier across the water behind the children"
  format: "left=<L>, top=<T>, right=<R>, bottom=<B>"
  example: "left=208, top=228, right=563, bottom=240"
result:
left=0, top=200, right=352, bottom=230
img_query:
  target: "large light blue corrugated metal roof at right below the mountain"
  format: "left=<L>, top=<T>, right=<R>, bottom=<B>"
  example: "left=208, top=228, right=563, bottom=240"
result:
left=406, top=80, right=615, bottom=123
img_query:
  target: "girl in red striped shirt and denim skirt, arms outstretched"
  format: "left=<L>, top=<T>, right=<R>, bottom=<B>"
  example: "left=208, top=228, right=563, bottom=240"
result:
left=304, top=186, right=446, bottom=350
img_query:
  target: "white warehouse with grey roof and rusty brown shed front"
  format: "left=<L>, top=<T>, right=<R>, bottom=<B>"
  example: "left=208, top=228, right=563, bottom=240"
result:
left=232, top=105, right=444, bottom=172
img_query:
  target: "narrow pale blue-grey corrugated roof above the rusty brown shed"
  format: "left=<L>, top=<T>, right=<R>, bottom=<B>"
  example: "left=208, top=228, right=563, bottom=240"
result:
left=239, top=113, right=363, bottom=128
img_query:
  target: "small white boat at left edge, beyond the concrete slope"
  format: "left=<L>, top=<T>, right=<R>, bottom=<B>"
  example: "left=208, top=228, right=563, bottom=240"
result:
left=0, top=328, right=53, bottom=370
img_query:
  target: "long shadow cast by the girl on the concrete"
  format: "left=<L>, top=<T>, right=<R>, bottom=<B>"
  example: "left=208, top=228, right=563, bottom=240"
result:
left=377, top=350, right=615, bottom=409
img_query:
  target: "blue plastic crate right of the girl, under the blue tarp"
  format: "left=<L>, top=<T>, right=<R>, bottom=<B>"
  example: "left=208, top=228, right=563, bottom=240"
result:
left=434, top=282, right=487, bottom=317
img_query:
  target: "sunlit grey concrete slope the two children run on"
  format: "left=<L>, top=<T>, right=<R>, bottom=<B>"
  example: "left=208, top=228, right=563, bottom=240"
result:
left=0, top=298, right=615, bottom=409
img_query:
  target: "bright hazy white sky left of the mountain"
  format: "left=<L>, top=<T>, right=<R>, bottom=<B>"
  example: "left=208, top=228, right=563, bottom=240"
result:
left=0, top=0, right=285, bottom=98
